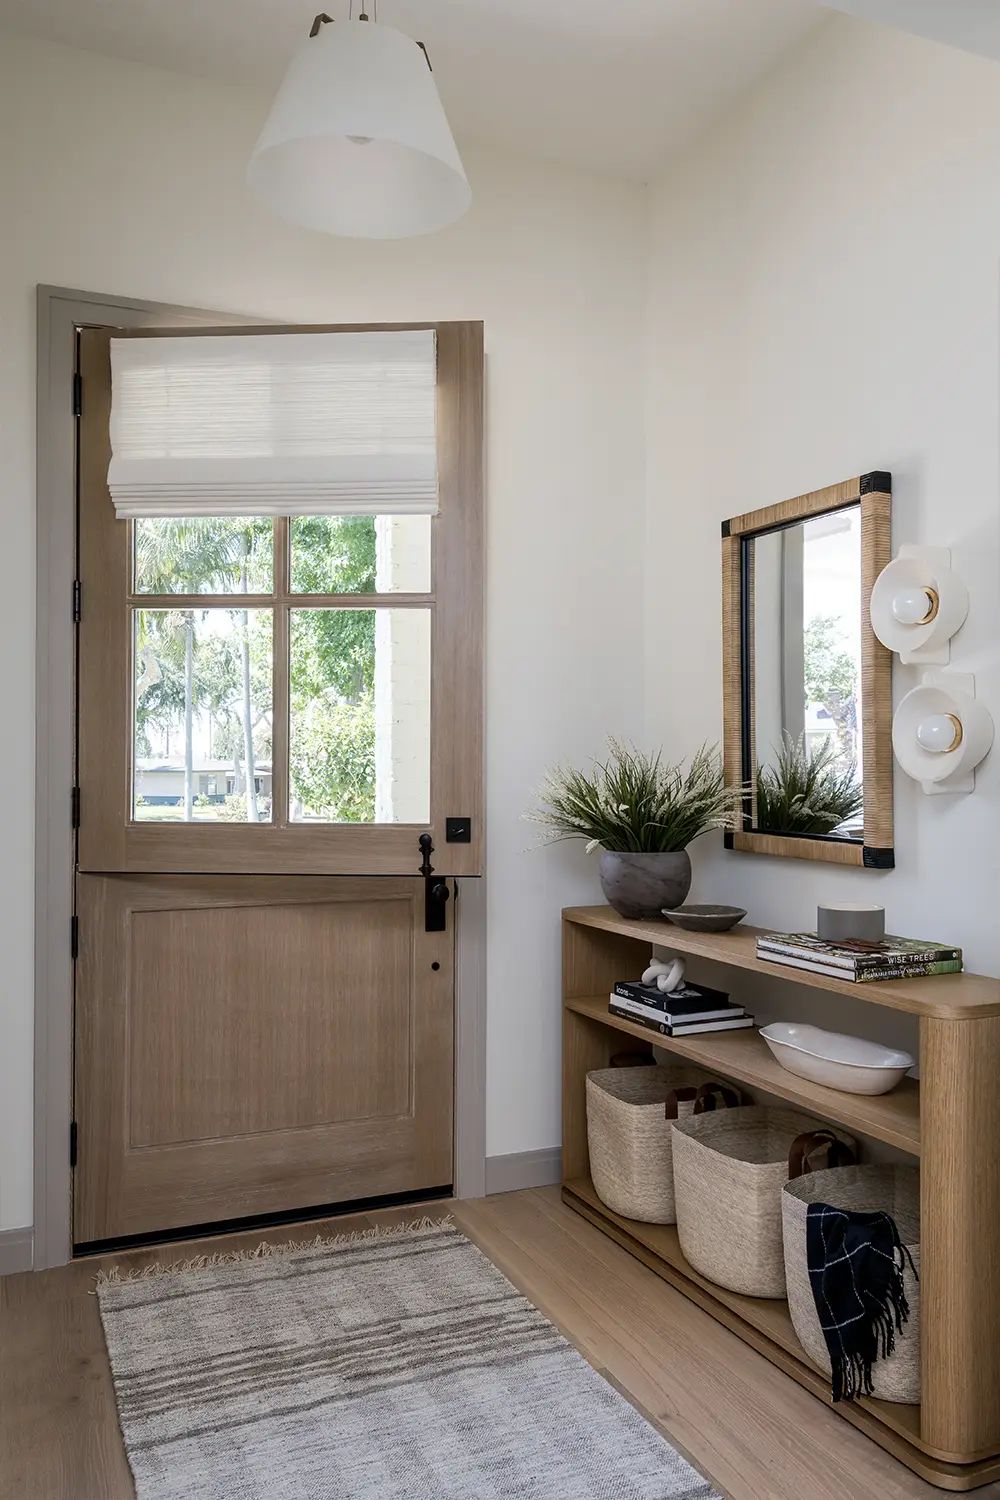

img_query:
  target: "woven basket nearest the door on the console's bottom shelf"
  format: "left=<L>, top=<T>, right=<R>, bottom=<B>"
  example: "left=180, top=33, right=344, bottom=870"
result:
left=586, top=1064, right=738, bottom=1224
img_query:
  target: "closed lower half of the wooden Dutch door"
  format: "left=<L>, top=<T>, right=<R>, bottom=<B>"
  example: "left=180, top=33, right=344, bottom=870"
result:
left=75, top=875, right=454, bottom=1244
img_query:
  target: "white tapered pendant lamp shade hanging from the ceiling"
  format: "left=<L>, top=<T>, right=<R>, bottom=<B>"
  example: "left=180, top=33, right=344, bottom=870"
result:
left=247, top=21, right=472, bottom=240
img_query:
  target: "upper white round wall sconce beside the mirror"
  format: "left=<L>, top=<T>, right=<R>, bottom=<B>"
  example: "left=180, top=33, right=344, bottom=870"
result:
left=870, top=546, right=969, bottom=666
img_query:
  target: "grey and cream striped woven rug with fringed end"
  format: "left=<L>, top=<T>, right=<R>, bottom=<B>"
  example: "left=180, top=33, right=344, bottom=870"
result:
left=97, top=1223, right=718, bottom=1500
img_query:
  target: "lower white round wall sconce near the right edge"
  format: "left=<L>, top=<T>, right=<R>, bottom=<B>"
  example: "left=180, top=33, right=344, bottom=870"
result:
left=886, top=675, right=993, bottom=794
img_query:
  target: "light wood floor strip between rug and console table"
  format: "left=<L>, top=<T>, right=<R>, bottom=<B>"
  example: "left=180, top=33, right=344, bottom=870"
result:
left=457, top=1190, right=959, bottom=1500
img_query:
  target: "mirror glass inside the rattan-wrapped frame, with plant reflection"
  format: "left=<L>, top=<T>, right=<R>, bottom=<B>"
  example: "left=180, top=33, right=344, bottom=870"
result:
left=744, top=506, right=864, bottom=842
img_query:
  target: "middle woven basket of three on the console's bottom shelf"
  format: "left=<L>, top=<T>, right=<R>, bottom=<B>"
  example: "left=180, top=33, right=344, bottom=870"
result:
left=673, top=1106, right=855, bottom=1298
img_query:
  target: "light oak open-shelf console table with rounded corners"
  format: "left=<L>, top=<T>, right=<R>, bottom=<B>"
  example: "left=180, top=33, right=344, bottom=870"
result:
left=562, top=906, right=1000, bottom=1490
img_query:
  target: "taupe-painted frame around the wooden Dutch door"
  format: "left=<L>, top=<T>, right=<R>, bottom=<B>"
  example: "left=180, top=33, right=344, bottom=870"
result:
left=33, top=285, right=486, bottom=1271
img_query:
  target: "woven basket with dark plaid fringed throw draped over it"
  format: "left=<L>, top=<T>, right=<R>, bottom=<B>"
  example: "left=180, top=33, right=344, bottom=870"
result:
left=781, top=1167, right=921, bottom=1404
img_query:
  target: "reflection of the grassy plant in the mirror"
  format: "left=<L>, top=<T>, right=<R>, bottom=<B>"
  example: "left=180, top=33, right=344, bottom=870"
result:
left=757, top=734, right=864, bottom=834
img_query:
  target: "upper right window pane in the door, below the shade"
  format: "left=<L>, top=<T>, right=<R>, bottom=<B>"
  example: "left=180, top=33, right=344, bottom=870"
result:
left=289, top=516, right=432, bottom=594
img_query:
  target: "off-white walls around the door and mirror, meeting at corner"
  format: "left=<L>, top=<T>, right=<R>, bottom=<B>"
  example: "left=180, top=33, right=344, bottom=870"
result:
left=7, top=17, right=1000, bottom=1227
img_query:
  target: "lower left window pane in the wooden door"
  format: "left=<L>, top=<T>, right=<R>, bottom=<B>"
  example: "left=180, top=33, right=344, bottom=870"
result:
left=132, top=608, right=273, bottom=824
